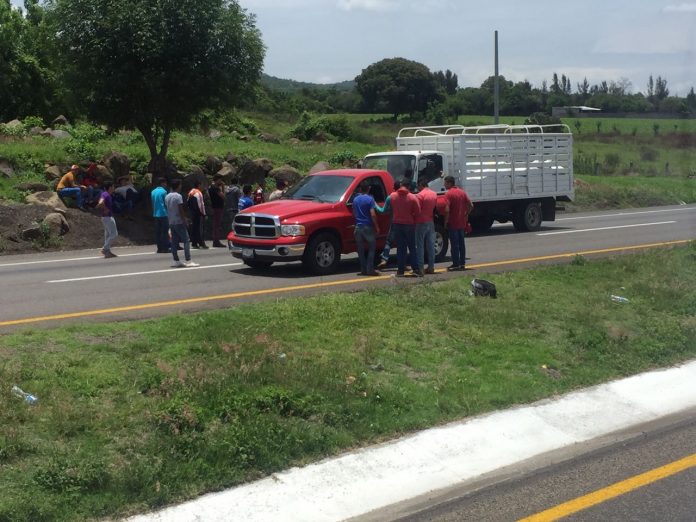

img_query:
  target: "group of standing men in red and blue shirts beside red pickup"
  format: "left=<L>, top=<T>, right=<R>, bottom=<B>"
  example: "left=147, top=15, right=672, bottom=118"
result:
left=353, top=176, right=474, bottom=277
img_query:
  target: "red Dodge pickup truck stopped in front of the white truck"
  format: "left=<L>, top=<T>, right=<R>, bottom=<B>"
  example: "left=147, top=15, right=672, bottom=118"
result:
left=227, top=169, right=447, bottom=274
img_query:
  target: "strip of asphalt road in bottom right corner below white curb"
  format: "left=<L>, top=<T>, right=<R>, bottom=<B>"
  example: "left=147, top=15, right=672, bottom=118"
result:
left=382, top=412, right=696, bottom=522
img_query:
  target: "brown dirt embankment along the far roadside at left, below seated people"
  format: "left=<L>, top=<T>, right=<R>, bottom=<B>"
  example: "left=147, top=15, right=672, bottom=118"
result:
left=0, top=201, right=154, bottom=255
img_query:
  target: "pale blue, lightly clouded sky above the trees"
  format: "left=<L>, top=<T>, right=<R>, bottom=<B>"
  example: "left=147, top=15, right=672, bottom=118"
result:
left=12, top=0, right=696, bottom=96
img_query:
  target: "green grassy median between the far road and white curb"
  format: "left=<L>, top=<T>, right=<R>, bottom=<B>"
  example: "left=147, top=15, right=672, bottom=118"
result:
left=0, top=243, right=696, bottom=521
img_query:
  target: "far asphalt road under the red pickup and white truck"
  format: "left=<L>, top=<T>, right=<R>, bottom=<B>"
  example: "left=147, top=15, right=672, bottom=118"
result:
left=0, top=205, right=696, bottom=324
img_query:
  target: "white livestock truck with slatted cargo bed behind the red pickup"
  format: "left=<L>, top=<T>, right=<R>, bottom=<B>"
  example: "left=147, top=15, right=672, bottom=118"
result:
left=363, top=125, right=574, bottom=234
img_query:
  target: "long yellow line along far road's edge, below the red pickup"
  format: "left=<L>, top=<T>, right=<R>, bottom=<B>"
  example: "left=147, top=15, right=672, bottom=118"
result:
left=0, top=240, right=691, bottom=327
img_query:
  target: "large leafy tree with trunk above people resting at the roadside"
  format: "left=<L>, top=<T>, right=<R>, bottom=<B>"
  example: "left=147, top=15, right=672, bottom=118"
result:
left=51, top=0, right=265, bottom=174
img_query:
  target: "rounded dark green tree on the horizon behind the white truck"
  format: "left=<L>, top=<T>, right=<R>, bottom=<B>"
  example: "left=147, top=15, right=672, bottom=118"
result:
left=355, top=58, right=439, bottom=119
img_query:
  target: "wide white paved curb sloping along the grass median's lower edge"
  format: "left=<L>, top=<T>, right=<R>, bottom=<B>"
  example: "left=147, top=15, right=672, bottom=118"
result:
left=128, top=361, right=696, bottom=522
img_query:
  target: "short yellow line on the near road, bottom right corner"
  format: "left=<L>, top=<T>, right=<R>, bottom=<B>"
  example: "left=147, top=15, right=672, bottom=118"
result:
left=519, top=453, right=696, bottom=522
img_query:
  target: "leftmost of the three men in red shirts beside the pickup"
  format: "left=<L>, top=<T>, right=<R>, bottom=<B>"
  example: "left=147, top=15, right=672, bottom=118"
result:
left=389, top=178, right=422, bottom=277
